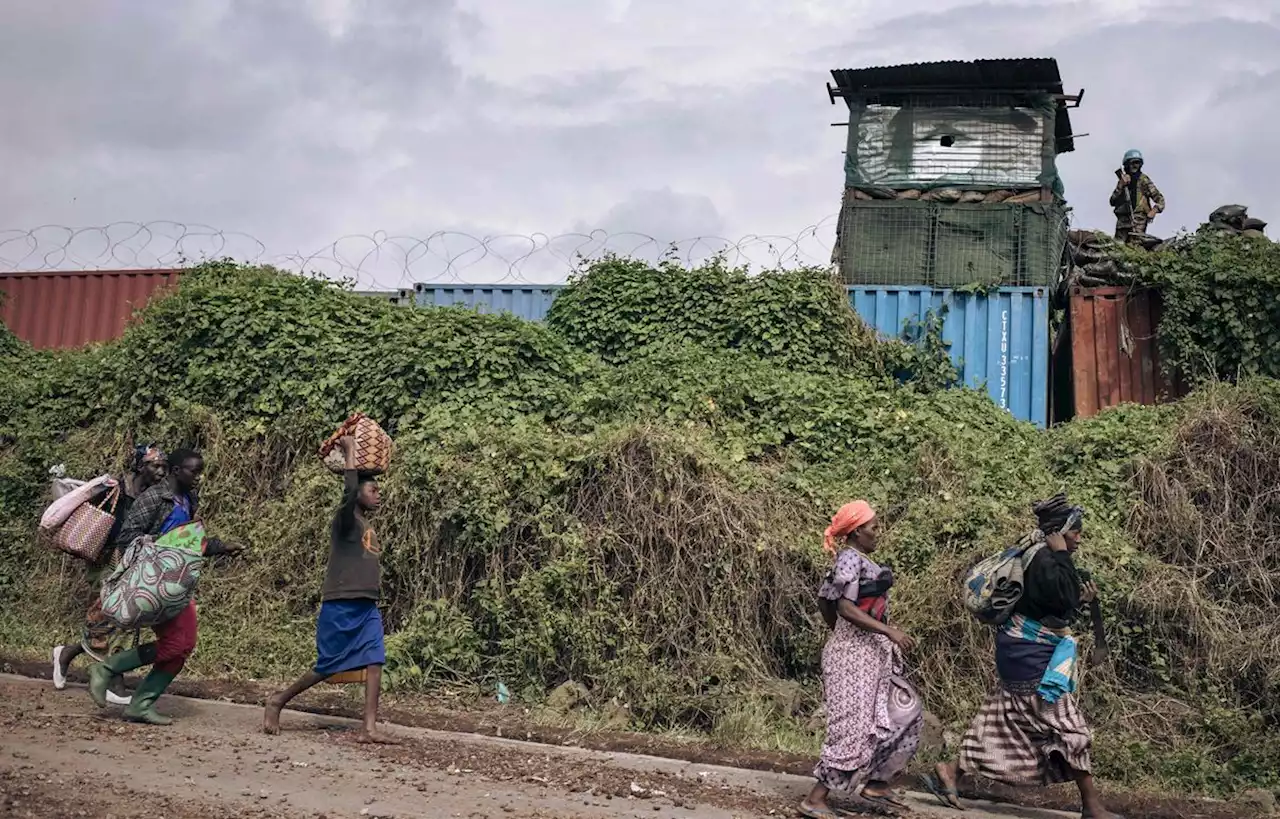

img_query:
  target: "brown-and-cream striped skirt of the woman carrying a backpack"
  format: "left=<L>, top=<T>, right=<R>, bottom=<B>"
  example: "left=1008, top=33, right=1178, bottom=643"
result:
left=960, top=686, right=1093, bottom=786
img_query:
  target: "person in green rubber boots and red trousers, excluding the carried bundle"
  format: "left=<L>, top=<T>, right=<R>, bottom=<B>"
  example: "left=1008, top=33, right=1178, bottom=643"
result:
left=88, top=449, right=239, bottom=726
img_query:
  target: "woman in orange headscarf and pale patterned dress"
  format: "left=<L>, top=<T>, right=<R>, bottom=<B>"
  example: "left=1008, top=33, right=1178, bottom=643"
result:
left=800, top=500, right=923, bottom=819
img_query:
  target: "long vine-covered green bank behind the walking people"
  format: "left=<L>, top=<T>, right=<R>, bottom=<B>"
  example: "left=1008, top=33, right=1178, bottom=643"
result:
left=0, top=260, right=1280, bottom=792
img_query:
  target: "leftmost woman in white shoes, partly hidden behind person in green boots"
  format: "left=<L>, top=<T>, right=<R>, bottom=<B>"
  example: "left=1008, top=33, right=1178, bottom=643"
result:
left=54, top=444, right=169, bottom=705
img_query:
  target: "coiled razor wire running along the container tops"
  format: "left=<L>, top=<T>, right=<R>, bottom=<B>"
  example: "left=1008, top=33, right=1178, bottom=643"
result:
left=0, top=215, right=838, bottom=289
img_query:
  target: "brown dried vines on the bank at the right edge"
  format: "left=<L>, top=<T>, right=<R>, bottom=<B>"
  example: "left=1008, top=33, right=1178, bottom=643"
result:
left=1132, top=386, right=1280, bottom=712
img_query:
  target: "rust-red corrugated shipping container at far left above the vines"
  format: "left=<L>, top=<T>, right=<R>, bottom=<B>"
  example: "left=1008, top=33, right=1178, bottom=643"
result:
left=0, top=270, right=182, bottom=349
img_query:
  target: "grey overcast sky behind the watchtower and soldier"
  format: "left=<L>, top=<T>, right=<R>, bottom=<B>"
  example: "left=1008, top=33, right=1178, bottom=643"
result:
left=0, top=0, right=1280, bottom=287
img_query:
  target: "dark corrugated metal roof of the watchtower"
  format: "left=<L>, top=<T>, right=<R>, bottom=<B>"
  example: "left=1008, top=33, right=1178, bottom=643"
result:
left=831, top=58, right=1075, bottom=152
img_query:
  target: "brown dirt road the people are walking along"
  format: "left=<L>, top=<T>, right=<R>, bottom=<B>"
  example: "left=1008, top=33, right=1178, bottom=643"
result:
left=0, top=676, right=1080, bottom=819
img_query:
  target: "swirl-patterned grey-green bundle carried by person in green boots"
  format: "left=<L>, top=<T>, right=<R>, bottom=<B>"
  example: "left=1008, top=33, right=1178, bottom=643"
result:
left=99, top=521, right=205, bottom=628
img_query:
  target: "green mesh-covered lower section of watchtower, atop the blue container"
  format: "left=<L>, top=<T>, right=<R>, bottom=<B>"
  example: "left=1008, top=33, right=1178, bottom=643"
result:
left=833, top=197, right=1068, bottom=288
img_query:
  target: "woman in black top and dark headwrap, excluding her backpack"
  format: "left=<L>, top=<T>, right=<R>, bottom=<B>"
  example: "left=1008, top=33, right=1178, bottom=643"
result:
left=925, top=494, right=1119, bottom=819
